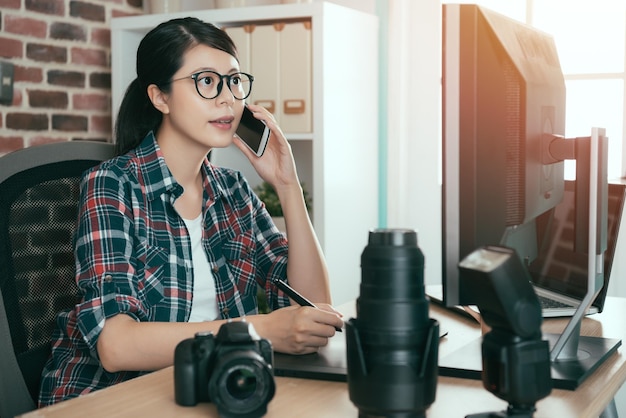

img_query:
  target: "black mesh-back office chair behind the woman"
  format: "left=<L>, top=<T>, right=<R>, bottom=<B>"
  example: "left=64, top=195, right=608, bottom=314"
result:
left=0, top=141, right=114, bottom=418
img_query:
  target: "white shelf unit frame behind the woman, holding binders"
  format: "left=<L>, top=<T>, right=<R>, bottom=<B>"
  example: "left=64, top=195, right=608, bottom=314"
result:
left=111, top=2, right=379, bottom=304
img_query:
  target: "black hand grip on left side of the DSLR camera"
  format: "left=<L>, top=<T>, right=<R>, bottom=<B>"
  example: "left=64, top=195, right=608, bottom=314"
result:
left=174, top=338, right=198, bottom=406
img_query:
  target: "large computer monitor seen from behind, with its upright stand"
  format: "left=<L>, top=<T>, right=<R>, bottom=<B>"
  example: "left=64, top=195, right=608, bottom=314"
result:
left=440, top=4, right=621, bottom=385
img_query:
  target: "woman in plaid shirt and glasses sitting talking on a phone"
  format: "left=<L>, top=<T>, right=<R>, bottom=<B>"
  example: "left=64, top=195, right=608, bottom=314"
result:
left=40, top=18, right=342, bottom=406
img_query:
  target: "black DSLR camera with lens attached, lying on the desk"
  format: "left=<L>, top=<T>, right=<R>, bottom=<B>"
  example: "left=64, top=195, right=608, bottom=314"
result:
left=174, top=321, right=276, bottom=418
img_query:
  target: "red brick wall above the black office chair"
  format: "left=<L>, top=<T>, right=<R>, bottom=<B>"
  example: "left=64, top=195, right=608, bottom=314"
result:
left=0, top=0, right=143, bottom=155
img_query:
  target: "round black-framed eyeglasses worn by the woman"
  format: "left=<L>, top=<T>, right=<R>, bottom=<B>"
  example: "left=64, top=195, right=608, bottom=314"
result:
left=166, top=70, right=254, bottom=100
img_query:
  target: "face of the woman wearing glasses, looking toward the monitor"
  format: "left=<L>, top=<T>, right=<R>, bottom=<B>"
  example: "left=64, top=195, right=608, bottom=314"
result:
left=158, top=45, right=244, bottom=153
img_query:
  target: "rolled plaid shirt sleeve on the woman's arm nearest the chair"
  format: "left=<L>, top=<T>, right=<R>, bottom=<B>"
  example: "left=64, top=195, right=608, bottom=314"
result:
left=75, top=162, right=165, bottom=348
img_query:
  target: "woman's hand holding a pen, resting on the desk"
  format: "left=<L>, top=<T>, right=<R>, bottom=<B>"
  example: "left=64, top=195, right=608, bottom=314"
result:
left=254, top=306, right=343, bottom=354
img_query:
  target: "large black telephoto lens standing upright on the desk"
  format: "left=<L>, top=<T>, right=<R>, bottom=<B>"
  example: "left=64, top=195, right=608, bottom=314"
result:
left=346, top=229, right=439, bottom=417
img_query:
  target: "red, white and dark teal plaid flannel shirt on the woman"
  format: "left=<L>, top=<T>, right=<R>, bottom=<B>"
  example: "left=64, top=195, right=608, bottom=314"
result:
left=39, top=133, right=289, bottom=406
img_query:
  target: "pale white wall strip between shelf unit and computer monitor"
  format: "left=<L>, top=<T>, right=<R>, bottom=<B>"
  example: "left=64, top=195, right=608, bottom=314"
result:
left=387, top=0, right=441, bottom=284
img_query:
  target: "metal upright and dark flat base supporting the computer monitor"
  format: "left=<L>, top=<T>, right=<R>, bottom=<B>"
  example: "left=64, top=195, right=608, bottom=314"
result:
left=439, top=128, right=622, bottom=390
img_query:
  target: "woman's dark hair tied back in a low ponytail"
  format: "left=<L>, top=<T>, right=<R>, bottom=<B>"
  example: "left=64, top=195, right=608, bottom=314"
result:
left=115, top=17, right=238, bottom=155
